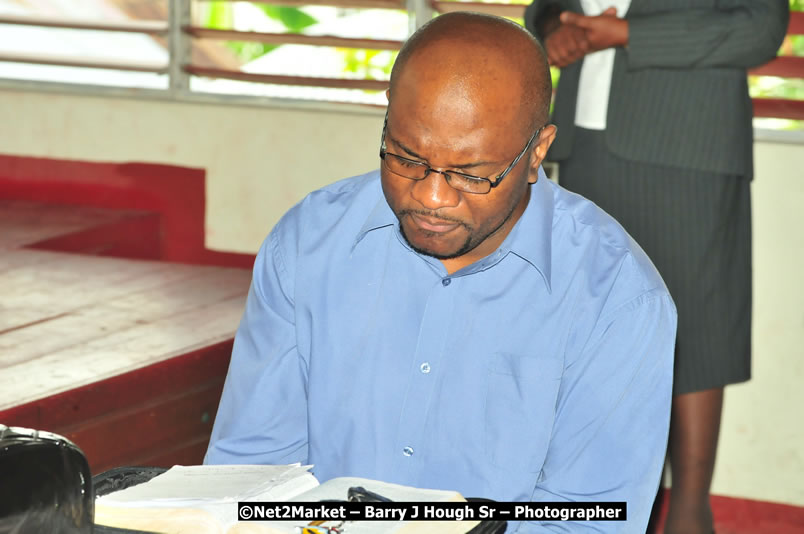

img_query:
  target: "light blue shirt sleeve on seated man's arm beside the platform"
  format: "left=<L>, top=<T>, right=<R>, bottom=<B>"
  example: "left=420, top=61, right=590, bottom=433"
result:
left=204, top=216, right=307, bottom=464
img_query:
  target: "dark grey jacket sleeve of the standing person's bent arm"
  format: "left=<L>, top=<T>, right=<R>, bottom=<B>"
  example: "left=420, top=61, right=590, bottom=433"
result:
left=626, top=0, right=790, bottom=70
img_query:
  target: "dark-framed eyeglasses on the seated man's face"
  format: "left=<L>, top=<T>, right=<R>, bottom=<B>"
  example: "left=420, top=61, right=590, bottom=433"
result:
left=380, top=113, right=544, bottom=195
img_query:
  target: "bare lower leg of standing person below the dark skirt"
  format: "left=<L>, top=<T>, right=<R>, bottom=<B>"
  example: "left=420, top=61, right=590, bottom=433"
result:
left=664, top=388, right=723, bottom=534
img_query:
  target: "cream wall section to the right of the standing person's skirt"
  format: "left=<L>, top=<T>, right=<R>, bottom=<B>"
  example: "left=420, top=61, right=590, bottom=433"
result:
left=712, top=138, right=804, bottom=505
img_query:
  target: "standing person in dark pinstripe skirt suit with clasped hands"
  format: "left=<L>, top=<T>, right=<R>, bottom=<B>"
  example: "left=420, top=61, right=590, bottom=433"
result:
left=525, top=0, right=789, bottom=534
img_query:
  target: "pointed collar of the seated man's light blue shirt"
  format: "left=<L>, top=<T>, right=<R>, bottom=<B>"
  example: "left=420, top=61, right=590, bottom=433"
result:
left=352, top=167, right=553, bottom=291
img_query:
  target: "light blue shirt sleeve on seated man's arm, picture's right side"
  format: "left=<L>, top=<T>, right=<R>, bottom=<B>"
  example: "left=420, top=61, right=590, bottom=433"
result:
left=518, top=290, right=676, bottom=533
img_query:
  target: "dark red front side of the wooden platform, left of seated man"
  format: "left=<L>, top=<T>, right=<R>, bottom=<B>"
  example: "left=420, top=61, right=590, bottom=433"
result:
left=0, top=340, right=232, bottom=473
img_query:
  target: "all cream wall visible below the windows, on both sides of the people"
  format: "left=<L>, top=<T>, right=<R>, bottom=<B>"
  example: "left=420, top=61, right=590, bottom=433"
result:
left=0, top=89, right=804, bottom=506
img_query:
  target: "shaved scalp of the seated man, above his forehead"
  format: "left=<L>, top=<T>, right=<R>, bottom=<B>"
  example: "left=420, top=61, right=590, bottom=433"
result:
left=389, top=12, right=552, bottom=130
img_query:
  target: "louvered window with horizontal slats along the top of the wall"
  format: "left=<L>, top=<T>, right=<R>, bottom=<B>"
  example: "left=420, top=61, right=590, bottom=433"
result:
left=0, top=0, right=804, bottom=123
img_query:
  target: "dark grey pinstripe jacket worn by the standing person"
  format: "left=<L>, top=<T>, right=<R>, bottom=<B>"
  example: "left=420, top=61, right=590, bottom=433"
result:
left=525, top=0, right=789, bottom=176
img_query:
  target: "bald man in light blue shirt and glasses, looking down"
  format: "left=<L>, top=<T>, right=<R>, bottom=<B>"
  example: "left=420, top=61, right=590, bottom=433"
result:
left=206, top=13, right=676, bottom=533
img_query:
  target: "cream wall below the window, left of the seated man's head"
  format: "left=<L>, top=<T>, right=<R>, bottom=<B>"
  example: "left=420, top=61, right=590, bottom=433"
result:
left=0, top=89, right=384, bottom=252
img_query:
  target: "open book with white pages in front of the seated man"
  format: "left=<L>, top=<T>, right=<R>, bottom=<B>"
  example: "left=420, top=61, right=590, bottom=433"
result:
left=95, top=464, right=478, bottom=534
